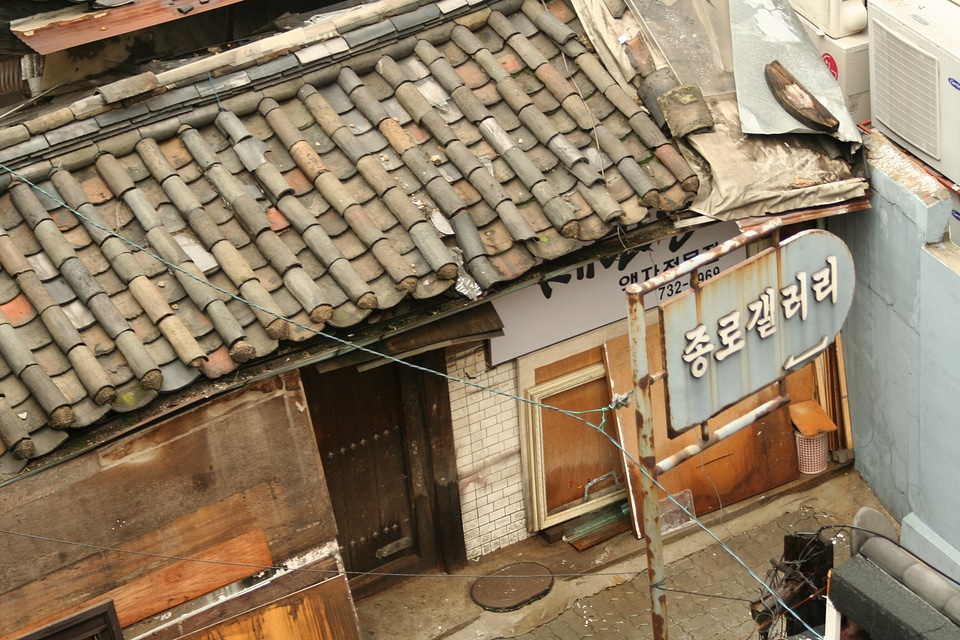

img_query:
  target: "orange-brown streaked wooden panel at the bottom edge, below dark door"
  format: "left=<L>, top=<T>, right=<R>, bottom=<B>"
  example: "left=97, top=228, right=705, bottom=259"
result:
left=184, top=576, right=360, bottom=640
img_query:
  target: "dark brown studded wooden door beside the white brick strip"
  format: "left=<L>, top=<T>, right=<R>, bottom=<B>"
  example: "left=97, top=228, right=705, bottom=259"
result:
left=303, top=364, right=435, bottom=582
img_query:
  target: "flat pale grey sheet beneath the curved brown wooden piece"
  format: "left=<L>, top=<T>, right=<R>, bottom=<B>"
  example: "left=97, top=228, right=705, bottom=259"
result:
left=730, top=0, right=861, bottom=143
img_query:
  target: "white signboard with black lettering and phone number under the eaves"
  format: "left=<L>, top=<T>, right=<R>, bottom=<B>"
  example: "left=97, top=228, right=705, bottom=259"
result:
left=490, top=222, right=746, bottom=365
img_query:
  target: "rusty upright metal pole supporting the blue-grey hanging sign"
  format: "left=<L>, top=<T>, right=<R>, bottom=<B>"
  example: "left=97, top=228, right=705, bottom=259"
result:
left=627, top=285, right=668, bottom=640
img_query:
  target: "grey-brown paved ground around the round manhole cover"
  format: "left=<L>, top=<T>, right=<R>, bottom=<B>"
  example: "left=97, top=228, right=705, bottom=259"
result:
left=357, top=466, right=883, bottom=640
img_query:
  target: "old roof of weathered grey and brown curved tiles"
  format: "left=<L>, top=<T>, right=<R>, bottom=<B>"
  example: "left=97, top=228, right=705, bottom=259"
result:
left=0, top=0, right=698, bottom=475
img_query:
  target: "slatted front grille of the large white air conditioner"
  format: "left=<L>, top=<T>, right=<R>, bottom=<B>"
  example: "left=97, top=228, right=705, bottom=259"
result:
left=870, top=21, right=940, bottom=160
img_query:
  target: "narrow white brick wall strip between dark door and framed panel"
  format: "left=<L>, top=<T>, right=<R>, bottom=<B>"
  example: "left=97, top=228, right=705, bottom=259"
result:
left=447, top=345, right=528, bottom=558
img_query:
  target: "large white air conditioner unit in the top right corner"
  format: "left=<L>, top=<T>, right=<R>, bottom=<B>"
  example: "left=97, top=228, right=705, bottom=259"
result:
left=869, top=0, right=960, bottom=182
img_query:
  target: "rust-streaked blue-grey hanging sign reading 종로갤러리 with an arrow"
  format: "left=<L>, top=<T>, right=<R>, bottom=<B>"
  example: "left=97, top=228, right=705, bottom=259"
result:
left=662, top=230, right=854, bottom=433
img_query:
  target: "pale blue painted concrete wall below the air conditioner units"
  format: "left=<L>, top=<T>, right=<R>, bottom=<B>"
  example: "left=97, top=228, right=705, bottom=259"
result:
left=828, top=136, right=960, bottom=577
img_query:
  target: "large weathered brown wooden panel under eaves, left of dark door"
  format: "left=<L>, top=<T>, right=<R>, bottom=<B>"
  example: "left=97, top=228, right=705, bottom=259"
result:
left=0, top=374, right=335, bottom=635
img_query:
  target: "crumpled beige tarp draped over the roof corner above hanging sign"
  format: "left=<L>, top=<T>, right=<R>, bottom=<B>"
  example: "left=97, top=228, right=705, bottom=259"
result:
left=681, top=99, right=867, bottom=220
